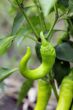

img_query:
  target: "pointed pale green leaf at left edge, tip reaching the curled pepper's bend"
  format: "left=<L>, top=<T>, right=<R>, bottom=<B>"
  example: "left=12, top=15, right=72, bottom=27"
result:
left=0, top=67, right=17, bottom=82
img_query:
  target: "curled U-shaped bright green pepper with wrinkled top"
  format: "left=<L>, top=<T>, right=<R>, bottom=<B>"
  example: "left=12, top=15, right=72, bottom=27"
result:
left=19, top=34, right=56, bottom=80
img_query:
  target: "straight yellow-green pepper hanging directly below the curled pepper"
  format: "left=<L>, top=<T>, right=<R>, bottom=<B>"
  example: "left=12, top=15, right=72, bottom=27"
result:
left=34, top=80, right=51, bottom=110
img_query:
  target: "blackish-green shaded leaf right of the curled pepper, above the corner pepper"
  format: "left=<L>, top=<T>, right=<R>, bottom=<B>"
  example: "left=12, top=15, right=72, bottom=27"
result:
left=53, top=58, right=70, bottom=85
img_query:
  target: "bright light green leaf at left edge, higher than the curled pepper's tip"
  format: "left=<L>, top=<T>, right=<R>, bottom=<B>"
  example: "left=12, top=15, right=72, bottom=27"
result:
left=0, top=36, right=14, bottom=55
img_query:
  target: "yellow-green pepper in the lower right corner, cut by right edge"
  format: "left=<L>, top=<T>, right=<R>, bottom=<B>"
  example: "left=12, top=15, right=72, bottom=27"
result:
left=56, top=69, right=73, bottom=110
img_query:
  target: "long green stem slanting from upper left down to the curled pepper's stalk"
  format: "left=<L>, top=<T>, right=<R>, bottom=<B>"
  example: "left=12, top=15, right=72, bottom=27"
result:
left=16, top=0, right=39, bottom=38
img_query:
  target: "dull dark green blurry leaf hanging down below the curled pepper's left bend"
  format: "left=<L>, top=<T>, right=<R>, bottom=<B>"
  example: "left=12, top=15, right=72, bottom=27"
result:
left=17, top=79, right=33, bottom=105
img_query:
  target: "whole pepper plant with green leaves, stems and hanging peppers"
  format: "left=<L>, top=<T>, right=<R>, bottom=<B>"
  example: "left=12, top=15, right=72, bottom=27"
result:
left=0, top=0, right=73, bottom=110
